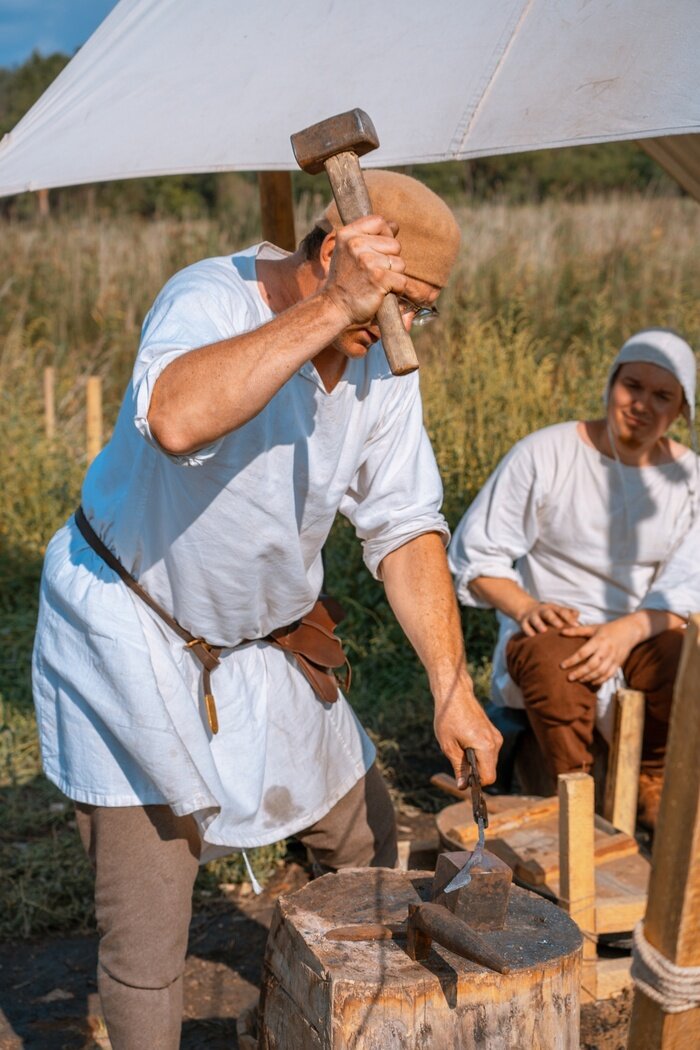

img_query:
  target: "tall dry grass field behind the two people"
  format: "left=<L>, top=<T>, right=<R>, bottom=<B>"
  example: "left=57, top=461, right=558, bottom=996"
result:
left=0, top=197, right=700, bottom=938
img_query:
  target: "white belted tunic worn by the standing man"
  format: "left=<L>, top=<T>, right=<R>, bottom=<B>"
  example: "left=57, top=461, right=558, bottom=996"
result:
left=34, top=246, right=447, bottom=860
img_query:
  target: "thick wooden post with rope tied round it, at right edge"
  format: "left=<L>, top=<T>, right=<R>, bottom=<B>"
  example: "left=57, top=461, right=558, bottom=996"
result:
left=628, top=614, right=700, bottom=1050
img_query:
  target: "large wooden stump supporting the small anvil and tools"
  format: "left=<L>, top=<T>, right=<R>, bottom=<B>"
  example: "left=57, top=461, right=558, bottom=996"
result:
left=260, top=868, right=581, bottom=1050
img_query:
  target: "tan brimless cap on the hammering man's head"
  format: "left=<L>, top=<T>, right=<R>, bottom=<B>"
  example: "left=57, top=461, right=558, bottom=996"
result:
left=318, top=170, right=461, bottom=288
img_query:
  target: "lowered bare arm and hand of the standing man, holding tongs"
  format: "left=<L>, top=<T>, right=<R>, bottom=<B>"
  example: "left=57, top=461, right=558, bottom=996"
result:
left=381, top=532, right=502, bottom=788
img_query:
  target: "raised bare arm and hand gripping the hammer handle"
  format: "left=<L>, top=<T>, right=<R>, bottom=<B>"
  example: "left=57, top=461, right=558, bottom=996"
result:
left=148, top=215, right=406, bottom=455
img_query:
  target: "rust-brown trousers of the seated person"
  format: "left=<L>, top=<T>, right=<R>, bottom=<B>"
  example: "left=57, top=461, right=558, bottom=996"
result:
left=506, top=628, right=683, bottom=777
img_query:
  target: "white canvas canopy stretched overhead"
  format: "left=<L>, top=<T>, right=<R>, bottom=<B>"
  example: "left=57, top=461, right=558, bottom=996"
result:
left=0, top=0, right=700, bottom=197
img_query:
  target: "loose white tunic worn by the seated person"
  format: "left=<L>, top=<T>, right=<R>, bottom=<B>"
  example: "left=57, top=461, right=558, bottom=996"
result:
left=449, top=422, right=700, bottom=736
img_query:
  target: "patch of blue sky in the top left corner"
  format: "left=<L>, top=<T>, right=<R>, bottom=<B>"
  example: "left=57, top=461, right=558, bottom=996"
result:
left=0, top=0, right=116, bottom=66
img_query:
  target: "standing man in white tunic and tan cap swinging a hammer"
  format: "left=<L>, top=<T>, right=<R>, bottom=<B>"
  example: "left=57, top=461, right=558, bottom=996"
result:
left=34, top=172, right=501, bottom=1050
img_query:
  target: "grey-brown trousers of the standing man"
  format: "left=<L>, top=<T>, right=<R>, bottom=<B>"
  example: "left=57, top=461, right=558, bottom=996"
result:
left=77, top=765, right=397, bottom=1050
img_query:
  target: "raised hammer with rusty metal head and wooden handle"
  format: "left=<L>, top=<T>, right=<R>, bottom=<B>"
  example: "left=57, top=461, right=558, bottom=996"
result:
left=292, top=109, right=418, bottom=376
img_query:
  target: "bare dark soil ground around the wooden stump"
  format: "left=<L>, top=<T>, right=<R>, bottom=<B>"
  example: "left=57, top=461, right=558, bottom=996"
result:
left=0, top=811, right=631, bottom=1050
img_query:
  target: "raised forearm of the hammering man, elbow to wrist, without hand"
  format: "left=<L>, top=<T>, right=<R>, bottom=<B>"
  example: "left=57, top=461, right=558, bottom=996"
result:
left=148, top=292, right=347, bottom=455
